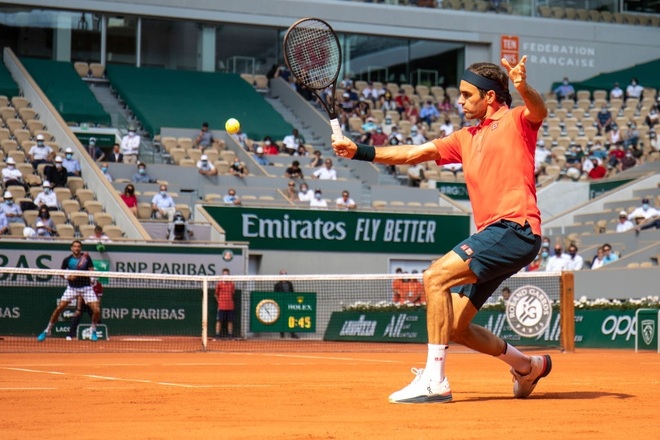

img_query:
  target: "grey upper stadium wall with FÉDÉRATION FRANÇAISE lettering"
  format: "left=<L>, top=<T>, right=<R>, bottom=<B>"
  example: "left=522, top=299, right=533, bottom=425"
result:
left=12, top=0, right=660, bottom=90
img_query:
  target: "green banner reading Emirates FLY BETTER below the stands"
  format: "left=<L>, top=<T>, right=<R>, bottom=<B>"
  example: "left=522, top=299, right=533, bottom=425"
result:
left=205, top=206, right=470, bottom=254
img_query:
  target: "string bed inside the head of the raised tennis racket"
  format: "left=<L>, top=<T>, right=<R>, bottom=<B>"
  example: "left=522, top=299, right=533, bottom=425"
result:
left=285, top=22, right=341, bottom=90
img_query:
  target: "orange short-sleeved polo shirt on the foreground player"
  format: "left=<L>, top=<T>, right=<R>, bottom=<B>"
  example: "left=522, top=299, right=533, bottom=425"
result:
left=433, top=106, right=541, bottom=235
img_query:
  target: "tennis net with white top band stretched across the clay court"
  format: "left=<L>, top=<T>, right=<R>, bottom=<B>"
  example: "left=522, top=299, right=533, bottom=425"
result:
left=0, top=267, right=574, bottom=352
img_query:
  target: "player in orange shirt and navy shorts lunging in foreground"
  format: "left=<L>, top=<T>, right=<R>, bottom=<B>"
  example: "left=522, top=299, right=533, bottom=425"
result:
left=332, top=56, right=552, bottom=403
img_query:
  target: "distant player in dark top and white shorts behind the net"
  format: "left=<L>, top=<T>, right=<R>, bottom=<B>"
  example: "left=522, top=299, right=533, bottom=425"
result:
left=37, top=240, right=101, bottom=342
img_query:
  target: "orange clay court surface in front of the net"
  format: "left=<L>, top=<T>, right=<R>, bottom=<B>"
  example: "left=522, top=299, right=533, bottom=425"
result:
left=0, top=345, right=660, bottom=440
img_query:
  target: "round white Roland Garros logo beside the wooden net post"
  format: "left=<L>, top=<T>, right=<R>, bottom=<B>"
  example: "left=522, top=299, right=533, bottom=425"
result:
left=506, top=286, right=552, bottom=338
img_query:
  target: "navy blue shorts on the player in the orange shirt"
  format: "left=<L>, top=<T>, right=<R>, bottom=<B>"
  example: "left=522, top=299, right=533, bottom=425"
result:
left=452, top=220, right=541, bottom=310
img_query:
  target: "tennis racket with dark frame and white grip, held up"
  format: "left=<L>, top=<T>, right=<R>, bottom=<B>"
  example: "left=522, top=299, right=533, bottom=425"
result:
left=284, top=18, right=344, bottom=139
